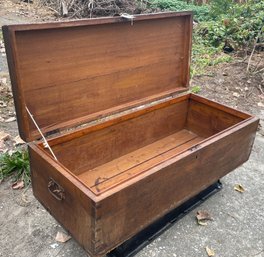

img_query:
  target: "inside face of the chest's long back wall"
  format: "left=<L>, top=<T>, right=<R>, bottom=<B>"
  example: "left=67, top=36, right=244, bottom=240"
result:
left=52, top=100, right=188, bottom=175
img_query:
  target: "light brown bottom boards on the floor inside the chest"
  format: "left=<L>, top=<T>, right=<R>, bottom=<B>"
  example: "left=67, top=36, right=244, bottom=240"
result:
left=78, top=130, right=202, bottom=193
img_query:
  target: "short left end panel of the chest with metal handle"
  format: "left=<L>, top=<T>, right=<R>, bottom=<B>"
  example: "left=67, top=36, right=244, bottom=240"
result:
left=29, top=144, right=95, bottom=254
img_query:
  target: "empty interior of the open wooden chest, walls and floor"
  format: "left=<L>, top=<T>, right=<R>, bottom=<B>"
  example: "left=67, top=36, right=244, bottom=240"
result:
left=40, top=95, right=250, bottom=195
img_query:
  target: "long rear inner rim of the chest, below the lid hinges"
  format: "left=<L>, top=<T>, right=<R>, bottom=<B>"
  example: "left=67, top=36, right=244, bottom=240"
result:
left=44, top=89, right=189, bottom=146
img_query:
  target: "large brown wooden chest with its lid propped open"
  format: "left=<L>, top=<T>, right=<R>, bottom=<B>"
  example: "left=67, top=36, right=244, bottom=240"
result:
left=3, top=12, right=258, bottom=257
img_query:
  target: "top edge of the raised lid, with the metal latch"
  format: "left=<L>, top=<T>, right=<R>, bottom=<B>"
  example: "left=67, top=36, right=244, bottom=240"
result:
left=3, top=11, right=192, bottom=31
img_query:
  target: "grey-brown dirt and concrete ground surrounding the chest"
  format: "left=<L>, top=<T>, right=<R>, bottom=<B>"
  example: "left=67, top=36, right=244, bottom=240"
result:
left=0, top=0, right=264, bottom=257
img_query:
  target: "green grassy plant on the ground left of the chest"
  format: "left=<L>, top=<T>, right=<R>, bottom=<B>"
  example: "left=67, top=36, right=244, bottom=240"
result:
left=0, top=150, right=30, bottom=185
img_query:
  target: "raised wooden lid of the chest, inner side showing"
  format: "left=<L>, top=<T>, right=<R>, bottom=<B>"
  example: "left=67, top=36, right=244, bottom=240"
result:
left=3, top=12, right=192, bottom=141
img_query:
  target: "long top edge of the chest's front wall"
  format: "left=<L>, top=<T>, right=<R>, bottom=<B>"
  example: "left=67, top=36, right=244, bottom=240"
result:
left=94, top=117, right=259, bottom=201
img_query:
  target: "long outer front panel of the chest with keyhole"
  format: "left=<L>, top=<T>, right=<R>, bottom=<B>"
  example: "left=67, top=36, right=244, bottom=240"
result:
left=92, top=119, right=258, bottom=253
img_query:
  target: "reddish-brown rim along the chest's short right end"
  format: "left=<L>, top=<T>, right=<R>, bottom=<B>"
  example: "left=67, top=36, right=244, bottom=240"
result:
left=190, top=93, right=254, bottom=119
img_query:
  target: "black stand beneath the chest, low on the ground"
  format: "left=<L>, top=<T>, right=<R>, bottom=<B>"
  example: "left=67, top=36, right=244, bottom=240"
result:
left=107, top=181, right=222, bottom=257
